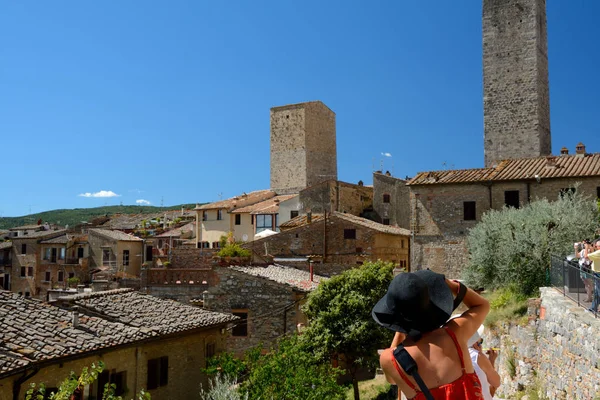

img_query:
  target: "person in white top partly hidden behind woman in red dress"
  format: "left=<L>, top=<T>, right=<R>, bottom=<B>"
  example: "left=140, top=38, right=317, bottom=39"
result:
left=467, top=325, right=500, bottom=400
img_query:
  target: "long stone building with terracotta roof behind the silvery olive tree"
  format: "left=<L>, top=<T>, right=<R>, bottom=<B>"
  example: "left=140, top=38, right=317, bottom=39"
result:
left=407, top=148, right=600, bottom=277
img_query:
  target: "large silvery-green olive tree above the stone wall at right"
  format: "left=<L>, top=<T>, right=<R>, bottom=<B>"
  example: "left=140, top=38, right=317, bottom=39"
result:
left=463, top=186, right=599, bottom=295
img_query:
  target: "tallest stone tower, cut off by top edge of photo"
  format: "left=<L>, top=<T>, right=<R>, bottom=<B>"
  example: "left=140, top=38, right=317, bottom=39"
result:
left=483, top=0, right=552, bottom=167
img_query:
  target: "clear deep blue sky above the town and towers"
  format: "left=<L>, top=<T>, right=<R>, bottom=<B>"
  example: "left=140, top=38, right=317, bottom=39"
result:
left=0, top=0, right=600, bottom=216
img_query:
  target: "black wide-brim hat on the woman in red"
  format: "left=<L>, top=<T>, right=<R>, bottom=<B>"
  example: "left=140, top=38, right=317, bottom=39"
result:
left=371, top=270, right=454, bottom=336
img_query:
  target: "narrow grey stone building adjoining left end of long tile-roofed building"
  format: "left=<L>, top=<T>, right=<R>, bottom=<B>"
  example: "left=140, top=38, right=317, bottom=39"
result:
left=373, top=171, right=410, bottom=229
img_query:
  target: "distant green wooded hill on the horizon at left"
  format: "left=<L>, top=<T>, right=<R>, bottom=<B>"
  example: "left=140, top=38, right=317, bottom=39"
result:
left=0, top=204, right=196, bottom=229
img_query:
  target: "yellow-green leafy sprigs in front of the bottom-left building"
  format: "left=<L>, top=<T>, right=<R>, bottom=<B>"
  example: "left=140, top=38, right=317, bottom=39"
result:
left=25, top=361, right=151, bottom=400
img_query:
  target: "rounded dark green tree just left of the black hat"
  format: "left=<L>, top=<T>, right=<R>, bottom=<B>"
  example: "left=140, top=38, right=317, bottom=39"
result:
left=302, top=261, right=394, bottom=400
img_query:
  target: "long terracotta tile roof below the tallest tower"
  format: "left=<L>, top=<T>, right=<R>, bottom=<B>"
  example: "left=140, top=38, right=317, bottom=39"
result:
left=407, top=153, right=600, bottom=185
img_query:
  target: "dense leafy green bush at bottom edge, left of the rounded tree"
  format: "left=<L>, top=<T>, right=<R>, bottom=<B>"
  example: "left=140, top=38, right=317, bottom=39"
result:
left=241, top=335, right=345, bottom=400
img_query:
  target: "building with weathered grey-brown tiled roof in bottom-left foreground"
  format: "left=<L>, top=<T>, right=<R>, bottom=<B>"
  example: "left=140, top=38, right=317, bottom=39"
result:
left=0, top=289, right=237, bottom=400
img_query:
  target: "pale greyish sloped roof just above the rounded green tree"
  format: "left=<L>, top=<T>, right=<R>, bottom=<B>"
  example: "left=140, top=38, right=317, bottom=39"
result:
left=229, top=264, right=327, bottom=292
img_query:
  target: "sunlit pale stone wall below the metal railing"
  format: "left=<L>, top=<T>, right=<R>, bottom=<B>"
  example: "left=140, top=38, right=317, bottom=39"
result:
left=484, top=288, right=600, bottom=400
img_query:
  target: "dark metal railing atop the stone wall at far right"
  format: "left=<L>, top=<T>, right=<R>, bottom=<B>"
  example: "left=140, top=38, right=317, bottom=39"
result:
left=549, top=255, right=600, bottom=317
